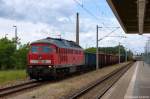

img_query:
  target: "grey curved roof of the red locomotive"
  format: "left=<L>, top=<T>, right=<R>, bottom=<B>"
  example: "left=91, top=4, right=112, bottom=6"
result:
left=31, top=37, right=82, bottom=49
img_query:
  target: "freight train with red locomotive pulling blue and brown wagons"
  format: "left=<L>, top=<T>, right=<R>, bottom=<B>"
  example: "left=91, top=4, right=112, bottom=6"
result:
left=27, top=37, right=118, bottom=80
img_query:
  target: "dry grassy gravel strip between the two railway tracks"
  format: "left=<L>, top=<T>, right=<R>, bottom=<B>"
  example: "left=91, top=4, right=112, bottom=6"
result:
left=10, top=63, right=129, bottom=99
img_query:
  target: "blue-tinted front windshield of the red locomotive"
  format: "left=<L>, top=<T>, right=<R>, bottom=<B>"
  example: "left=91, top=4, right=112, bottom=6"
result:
left=31, top=46, right=52, bottom=53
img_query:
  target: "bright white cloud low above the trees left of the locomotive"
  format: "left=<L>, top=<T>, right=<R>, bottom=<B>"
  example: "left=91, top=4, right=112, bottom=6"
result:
left=0, top=18, right=54, bottom=43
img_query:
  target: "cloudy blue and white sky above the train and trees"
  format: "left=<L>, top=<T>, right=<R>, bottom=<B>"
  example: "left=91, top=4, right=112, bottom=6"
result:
left=0, top=0, right=149, bottom=53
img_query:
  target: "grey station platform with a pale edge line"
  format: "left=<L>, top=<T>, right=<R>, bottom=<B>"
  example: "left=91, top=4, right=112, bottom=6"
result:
left=102, top=61, right=150, bottom=99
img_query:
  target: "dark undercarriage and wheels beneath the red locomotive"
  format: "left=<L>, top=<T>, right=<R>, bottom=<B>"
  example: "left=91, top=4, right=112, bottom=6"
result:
left=27, top=65, right=87, bottom=80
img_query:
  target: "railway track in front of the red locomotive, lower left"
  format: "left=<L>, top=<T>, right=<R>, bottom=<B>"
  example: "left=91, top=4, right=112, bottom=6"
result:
left=0, top=80, right=42, bottom=98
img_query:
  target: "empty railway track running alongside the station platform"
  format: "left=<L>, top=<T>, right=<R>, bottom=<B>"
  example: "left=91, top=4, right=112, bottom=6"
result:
left=63, top=63, right=133, bottom=99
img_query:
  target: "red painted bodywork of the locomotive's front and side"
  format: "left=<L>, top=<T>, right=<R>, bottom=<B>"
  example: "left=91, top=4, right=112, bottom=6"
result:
left=28, top=43, right=84, bottom=67
